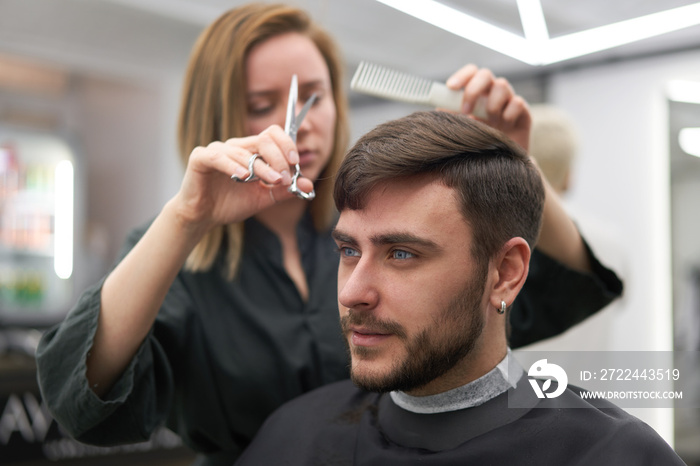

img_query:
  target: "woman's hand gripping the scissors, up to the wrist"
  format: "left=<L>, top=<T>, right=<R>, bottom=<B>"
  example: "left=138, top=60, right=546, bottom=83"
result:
left=173, top=125, right=313, bottom=229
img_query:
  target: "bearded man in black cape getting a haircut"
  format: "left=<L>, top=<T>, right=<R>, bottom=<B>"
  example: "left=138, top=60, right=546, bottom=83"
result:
left=235, top=112, right=683, bottom=466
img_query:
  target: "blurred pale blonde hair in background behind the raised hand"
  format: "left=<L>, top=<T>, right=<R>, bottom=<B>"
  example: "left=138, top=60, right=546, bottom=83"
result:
left=530, top=104, right=578, bottom=193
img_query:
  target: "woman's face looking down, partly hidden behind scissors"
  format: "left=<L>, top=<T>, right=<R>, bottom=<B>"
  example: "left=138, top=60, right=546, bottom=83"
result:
left=246, top=33, right=336, bottom=181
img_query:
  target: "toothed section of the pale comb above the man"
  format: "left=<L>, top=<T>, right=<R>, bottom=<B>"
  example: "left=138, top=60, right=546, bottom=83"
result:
left=350, top=62, right=433, bottom=104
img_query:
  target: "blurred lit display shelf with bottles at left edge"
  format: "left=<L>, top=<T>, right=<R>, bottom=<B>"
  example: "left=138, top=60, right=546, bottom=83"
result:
left=0, top=125, right=76, bottom=325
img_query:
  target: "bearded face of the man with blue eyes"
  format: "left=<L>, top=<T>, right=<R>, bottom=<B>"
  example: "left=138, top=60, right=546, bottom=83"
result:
left=334, top=176, right=488, bottom=395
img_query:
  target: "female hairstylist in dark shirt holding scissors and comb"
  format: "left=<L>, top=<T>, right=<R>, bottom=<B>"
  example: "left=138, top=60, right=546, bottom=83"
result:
left=37, top=1, right=620, bottom=464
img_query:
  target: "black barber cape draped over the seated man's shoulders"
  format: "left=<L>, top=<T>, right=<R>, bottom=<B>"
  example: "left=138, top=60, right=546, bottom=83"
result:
left=236, top=375, right=685, bottom=466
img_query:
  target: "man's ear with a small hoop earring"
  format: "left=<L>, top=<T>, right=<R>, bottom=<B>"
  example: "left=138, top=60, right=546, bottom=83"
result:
left=489, top=237, right=530, bottom=309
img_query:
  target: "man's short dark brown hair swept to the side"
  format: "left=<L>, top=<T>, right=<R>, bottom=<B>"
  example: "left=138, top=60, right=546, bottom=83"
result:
left=334, top=111, right=544, bottom=261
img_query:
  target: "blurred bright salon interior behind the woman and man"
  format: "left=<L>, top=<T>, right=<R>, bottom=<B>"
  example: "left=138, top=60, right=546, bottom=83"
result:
left=0, top=0, right=700, bottom=465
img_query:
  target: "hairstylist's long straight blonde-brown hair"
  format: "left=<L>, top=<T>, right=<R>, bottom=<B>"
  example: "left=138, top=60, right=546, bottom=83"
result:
left=178, top=4, right=349, bottom=279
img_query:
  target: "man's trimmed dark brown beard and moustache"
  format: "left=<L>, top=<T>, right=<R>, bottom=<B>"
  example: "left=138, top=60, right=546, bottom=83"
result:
left=341, top=267, right=486, bottom=393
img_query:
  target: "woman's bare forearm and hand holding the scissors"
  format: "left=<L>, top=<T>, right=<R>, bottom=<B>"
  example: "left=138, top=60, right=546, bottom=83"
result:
left=86, top=125, right=313, bottom=396
